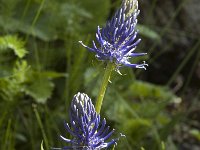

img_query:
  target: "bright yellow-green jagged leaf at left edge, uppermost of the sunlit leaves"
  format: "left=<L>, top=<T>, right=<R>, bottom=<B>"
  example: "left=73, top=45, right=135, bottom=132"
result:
left=0, top=35, right=27, bottom=58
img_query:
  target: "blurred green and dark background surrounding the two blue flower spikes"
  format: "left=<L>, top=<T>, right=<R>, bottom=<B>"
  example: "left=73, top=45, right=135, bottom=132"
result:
left=0, top=0, right=200, bottom=150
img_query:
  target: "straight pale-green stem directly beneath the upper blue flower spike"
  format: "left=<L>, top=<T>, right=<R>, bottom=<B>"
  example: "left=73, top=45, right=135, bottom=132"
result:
left=95, top=62, right=115, bottom=113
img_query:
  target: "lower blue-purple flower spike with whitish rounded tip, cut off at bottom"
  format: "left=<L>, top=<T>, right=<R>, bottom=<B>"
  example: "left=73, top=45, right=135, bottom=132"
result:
left=60, top=93, right=118, bottom=150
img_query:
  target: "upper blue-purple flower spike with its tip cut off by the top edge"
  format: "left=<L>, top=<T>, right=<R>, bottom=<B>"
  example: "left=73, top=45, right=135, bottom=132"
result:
left=79, top=0, right=148, bottom=69
